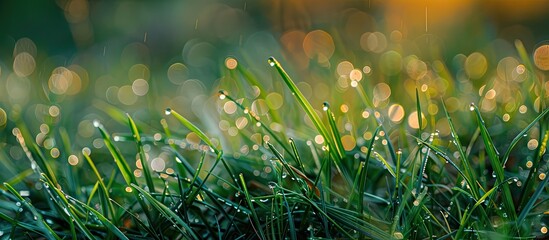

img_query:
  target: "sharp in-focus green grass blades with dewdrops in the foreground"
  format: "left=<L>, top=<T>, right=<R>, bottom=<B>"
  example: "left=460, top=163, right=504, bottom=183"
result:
left=0, top=49, right=549, bottom=239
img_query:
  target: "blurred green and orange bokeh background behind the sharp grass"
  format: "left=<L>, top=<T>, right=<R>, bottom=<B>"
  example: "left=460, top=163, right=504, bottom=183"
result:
left=0, top=0, right=549, bottom=184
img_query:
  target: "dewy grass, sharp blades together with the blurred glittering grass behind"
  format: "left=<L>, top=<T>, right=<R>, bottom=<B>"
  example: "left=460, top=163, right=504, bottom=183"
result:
left=0, top=10, right=549, bottom=239
